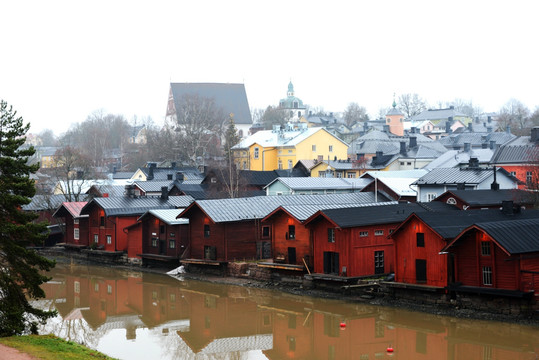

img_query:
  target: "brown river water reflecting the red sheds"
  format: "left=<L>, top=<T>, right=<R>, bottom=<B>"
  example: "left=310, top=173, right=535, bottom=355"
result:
left=35, top=265, right=539, bottom=360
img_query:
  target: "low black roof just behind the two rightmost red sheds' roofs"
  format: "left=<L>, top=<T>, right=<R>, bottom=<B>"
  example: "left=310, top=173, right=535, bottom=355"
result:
left=434, top=189, right=535, bottom=206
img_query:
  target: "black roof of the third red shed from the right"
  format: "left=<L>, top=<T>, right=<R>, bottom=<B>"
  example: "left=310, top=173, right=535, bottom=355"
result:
left=321, top=202, right=459, bottom=228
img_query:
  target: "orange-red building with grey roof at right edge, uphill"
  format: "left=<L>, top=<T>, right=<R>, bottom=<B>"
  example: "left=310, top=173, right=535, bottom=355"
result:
left=491, top=127, right=539, bottom=190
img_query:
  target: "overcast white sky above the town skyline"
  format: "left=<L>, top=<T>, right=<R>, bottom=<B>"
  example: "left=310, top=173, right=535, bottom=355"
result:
left=0, top=0, right=539, bottom=134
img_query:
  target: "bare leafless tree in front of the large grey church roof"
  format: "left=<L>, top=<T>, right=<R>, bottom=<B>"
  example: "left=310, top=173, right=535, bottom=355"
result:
left=175, top=94, right=225, bottom=164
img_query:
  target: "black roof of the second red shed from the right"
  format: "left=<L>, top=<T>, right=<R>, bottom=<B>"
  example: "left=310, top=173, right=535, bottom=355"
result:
left=415, top=207, right=539, bottom=239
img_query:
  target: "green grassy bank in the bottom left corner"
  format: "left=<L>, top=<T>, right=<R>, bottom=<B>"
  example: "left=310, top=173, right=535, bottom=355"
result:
left=0, top=335, right=117, bottom=360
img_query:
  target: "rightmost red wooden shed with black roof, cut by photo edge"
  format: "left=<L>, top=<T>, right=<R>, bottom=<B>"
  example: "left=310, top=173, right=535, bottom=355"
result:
left=442, top=216, right=539, bottom=300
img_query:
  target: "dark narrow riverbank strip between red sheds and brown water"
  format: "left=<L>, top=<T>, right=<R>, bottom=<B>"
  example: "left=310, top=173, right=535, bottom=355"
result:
left=42, top=250, right=539, bottom=326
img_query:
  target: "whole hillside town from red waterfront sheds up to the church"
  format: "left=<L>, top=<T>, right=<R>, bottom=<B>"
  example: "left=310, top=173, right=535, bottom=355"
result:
left=23, top=82, right=539, bottom=314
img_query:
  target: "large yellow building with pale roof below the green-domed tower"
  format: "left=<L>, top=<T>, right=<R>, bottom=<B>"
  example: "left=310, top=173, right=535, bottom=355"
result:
left=232, top=124, right=348, bottom=171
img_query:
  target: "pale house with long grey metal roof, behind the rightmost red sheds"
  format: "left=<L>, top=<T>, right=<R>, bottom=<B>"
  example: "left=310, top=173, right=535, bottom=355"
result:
left=412, top=167, right=519, bottom=202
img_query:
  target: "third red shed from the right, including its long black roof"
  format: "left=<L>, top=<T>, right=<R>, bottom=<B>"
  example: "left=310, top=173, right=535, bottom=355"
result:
left=305, top=203, right=457, bottom=279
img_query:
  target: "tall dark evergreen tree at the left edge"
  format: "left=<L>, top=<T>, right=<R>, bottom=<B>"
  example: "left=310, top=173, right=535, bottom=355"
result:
left=0, top=100, right=55, bottom=336
